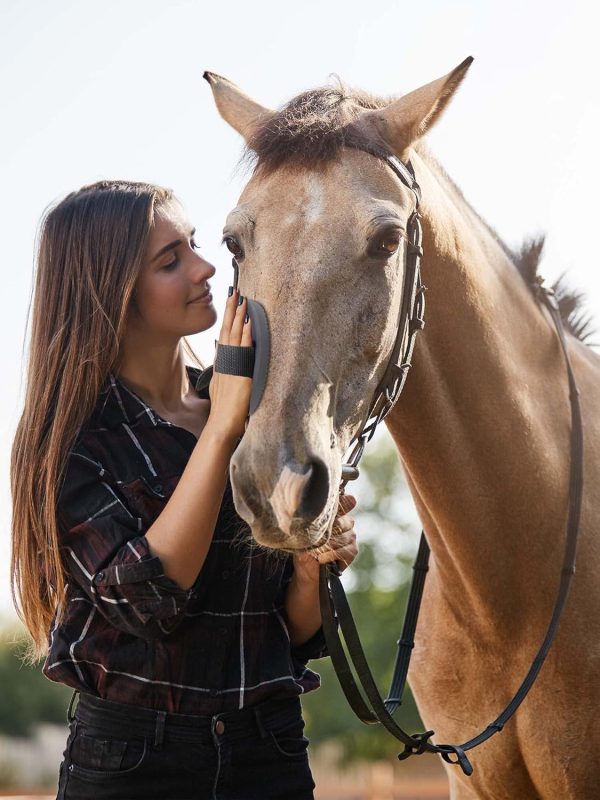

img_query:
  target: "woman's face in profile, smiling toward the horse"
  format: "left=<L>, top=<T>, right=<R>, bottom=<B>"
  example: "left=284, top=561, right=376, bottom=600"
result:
left=128, top=199, right=217, bottom=340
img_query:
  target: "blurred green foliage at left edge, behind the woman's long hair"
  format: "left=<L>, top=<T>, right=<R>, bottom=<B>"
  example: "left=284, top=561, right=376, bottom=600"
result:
left=0, top=634, right=72, bottom=736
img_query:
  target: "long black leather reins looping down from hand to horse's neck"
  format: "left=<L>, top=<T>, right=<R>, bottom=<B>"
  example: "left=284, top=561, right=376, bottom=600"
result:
left=319, top=208, right=583, bottom=775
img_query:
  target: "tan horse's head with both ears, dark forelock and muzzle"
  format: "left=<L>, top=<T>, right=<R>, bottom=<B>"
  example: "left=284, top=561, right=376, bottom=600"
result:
left=205, top=58, right=472, bottom=549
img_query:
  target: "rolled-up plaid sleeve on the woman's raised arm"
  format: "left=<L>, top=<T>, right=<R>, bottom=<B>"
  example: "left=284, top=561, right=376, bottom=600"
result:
left=57, top=451, right=193, bottom=638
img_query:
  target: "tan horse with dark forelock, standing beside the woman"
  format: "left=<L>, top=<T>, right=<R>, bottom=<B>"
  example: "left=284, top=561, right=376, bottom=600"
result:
left=204, top=58, right=600, bottom=800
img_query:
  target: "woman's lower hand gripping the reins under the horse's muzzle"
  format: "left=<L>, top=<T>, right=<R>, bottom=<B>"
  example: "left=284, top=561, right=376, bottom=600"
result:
left=294, top=494, right=358, bottom=583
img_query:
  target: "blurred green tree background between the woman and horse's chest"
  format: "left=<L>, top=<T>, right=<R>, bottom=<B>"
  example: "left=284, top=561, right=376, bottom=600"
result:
left=302, top=431, right=424, bottom=762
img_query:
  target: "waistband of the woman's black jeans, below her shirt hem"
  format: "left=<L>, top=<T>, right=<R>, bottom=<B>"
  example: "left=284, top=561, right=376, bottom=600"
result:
left=70, top=692, right=301, bottom=741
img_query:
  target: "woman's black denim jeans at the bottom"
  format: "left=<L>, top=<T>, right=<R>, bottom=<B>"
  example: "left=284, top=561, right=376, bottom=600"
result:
left=57, top=694, right=315, bottom=800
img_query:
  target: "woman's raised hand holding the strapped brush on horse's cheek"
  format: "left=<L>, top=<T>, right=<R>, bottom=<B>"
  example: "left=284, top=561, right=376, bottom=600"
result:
left=207, top=289, right=252, bottom=439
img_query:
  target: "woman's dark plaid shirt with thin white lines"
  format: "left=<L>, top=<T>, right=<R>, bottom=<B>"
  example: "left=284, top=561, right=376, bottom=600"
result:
left=43, top=366, right=326, bottom=715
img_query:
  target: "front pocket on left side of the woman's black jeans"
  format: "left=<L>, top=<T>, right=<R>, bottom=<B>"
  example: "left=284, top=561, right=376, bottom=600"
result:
left=68, top=729, right=148, bottom=780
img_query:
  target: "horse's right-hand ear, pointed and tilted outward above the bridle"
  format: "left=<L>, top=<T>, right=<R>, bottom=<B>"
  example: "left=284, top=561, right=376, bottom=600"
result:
left=361, top=56, right=473, bottom=155
